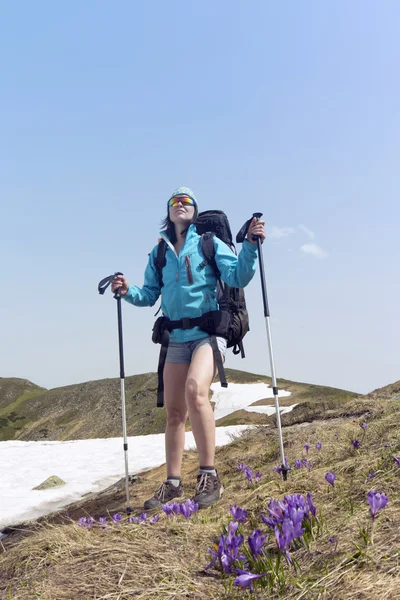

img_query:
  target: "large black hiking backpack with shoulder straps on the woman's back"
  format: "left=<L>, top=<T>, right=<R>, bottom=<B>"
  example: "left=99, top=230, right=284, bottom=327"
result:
left=153, top=210, right=249, bottom=406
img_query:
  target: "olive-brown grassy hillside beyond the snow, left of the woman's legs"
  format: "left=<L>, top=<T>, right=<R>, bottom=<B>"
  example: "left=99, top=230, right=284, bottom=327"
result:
left=0, top=373, right=165, bottom=440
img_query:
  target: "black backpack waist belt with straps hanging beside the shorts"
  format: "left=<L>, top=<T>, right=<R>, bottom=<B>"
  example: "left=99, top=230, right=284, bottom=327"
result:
left=157, top=311, right=228, bottom=408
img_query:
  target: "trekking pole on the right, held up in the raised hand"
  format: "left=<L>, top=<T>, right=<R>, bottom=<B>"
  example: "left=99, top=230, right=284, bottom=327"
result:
left=236, top=213, right=289, bottom=481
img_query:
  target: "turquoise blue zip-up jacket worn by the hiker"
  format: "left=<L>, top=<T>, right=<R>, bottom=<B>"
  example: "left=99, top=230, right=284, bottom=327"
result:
left=123, top=224, right=257, bottom=342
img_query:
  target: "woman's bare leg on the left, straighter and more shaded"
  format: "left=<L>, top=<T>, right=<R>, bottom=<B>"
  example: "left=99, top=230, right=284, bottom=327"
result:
left=164, top=363, right=190, bottom=477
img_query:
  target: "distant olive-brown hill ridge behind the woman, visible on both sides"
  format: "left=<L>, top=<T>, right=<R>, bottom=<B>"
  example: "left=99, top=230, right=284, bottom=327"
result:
left=0, top=369, right=357, bottom=441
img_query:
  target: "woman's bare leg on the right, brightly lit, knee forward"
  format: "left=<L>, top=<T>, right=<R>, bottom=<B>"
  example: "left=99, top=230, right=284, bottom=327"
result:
left=185, top=344, right=215, bottom=466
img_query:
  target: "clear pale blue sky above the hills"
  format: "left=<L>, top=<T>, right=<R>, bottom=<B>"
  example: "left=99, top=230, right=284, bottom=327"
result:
left=0, top=0, right=400, bottom=392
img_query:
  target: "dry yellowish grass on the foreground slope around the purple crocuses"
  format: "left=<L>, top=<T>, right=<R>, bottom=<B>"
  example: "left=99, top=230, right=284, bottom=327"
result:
left=0, top=398, right=400, bottom=600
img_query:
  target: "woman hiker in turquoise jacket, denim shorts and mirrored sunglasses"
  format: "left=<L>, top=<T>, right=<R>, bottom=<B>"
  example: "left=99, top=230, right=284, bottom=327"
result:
left=112, top=187, right=265, bottom=510
